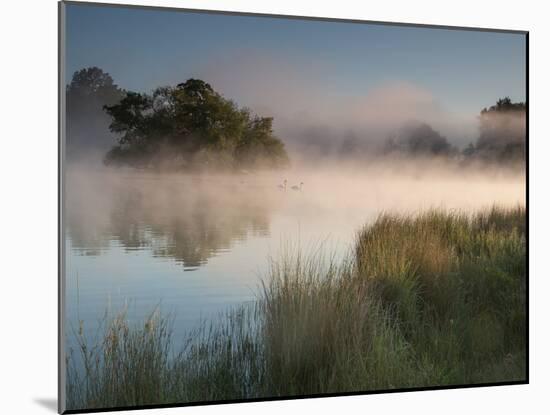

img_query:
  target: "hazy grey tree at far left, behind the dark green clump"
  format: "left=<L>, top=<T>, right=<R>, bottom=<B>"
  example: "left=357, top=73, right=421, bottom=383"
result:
left=66, top=67, right=123, bottom=159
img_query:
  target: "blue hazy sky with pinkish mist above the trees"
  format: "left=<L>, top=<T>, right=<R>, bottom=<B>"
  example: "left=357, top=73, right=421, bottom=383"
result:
left=66, top=5, right=526, bottom=145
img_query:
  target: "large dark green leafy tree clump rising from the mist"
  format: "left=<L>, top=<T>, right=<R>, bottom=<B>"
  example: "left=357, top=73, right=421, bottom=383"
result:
left=105, top=79, right=289, bottom=170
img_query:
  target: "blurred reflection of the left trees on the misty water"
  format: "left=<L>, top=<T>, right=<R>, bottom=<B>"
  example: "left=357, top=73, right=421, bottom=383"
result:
left=66, top=173, right=280, bottom=270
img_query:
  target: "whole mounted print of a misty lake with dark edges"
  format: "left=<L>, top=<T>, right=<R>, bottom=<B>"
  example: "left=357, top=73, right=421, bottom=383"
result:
left=59, top=2, right=528, bottom=413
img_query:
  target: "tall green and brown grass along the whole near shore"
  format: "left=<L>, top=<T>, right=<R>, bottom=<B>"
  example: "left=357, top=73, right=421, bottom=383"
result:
left=67, top=207, right=527, bottom=409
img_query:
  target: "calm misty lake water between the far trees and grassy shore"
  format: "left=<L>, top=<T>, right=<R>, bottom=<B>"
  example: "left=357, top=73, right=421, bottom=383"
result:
left=65, top=169, right=525, bottom=346
